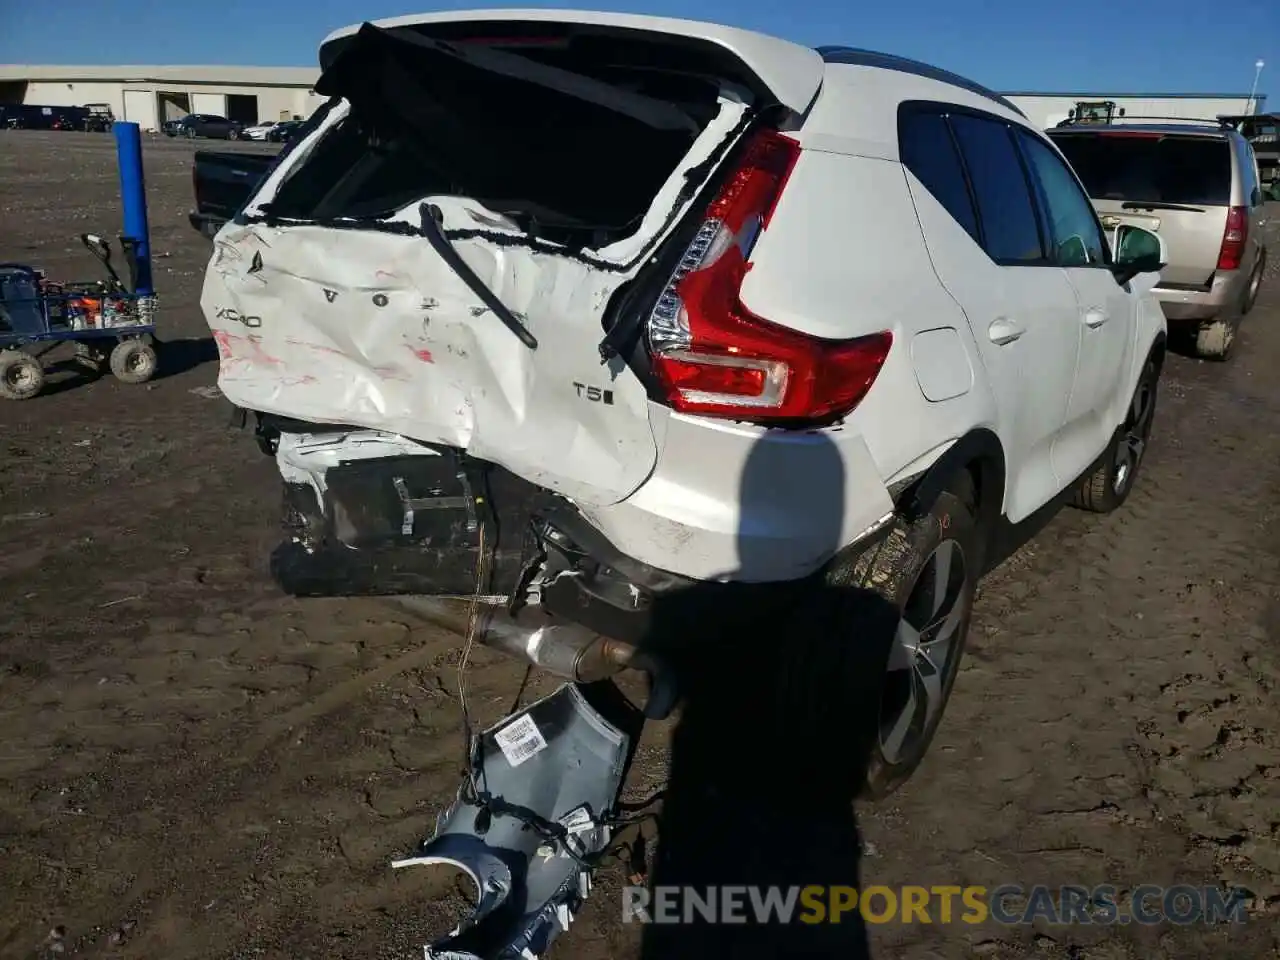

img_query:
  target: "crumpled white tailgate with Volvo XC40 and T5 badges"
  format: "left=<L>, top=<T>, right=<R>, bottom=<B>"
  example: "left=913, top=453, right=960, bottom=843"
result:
left=201, top=100, right=746, bottom=506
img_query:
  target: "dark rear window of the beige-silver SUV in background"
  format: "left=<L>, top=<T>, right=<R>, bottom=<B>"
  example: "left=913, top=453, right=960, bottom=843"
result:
left=1053, top=134, right=1231, bottom=206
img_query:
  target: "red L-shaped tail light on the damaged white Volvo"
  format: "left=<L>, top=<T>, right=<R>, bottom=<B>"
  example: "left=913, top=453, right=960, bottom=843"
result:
left=646, top=131, right=893, bottom=422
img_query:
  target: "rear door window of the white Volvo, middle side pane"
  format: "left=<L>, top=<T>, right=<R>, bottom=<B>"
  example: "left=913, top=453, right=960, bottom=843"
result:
left=950, top=114, right=1044, bottom=264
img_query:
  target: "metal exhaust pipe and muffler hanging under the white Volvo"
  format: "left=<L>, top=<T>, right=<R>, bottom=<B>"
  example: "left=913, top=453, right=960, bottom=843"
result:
left=396, top=596, right=677, bottom=719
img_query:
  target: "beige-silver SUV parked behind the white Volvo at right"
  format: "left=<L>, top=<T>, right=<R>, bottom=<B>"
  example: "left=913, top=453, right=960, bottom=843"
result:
left=1047, top=123, right=1267, bottom=360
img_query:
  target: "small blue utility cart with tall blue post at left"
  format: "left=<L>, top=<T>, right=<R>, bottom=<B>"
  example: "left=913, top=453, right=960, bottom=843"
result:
left=0, top=123, right=159, bottom=399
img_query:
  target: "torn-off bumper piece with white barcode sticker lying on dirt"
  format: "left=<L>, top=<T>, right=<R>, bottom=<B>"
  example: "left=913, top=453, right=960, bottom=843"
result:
left=392, top=684, right=630, bottom=960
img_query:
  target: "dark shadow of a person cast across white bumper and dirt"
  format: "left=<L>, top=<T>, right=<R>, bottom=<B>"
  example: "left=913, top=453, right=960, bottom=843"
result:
left=641, top=433, right=899, bottom=960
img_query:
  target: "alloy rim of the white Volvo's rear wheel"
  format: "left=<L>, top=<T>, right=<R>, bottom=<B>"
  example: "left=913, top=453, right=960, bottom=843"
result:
left=879, top=540, right=969, bottom=764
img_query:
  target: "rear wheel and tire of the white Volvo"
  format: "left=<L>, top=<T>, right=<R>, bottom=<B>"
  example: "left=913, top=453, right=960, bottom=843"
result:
left=828, top=471, right=983, bottom=800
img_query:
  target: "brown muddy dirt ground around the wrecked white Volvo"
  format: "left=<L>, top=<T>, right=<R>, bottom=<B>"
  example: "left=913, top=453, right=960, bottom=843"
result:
left=0, top=132, right=1280, bottom=960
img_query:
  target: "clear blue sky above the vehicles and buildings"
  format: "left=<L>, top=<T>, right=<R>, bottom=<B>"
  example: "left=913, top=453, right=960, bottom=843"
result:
left=0, top=0, right=1280, bottom=97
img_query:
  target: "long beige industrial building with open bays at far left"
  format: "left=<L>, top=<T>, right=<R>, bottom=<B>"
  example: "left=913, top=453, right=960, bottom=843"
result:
left=0, top=64, right=323, bottom=131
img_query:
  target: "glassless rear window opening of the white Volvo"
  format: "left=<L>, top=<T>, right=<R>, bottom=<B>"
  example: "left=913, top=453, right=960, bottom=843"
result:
left=266, top=27, right=742, bottom=243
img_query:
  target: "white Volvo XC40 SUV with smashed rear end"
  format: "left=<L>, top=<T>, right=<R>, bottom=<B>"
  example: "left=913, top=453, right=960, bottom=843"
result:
left=201, top=10, right=1166, bottom=796
